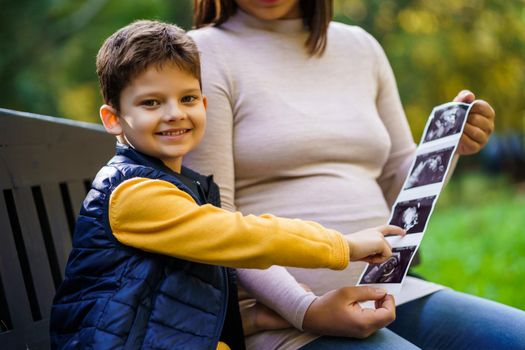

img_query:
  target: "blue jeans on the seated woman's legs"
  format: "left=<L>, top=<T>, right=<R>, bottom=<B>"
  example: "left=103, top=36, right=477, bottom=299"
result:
left=301, top=289, right=525, bottom=350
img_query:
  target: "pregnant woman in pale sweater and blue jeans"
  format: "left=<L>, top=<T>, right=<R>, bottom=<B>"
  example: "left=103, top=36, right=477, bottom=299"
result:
left=187, top=0, right=525, bottom=349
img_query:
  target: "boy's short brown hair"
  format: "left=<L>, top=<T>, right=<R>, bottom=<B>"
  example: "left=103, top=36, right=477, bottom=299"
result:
left=97, top=20, right=201, bottom=111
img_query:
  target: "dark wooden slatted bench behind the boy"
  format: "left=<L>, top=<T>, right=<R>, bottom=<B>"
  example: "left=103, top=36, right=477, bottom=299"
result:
left=0, top=108, right=115, bottom=349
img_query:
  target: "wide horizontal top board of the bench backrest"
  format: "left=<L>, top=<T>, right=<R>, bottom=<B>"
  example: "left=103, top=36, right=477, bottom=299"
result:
left=0, top=108, right=115, bottom=188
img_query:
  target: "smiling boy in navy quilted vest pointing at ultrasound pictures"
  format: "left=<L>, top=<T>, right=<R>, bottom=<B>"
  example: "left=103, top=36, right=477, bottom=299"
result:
left=51, top=21, right=402, bottom=349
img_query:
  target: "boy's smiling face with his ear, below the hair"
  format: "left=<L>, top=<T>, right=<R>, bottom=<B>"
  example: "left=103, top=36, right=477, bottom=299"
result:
left=100, top=62, right=207, bottom=172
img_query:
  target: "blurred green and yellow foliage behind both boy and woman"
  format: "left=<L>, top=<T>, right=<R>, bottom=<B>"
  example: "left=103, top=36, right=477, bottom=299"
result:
left=0, top=0, right=525, bottom=135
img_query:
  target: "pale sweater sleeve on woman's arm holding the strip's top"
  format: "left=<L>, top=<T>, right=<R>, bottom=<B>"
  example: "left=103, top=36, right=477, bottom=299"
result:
left=367, top=34, right=416, bottom=206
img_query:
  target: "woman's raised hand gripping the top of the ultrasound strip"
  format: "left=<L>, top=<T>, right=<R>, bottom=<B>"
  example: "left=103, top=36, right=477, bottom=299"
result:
left=454, top=90, right=496, bottom=155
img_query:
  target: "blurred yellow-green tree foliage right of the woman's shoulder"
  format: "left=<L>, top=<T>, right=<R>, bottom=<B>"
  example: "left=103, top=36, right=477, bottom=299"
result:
left=335, top=0, right=525, bottom=140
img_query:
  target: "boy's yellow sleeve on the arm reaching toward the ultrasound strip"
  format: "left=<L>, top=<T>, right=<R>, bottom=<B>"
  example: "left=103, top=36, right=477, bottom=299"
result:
left=109, top=178, right=350, bottom=269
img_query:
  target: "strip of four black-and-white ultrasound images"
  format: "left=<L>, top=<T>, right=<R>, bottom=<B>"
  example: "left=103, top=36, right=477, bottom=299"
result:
left=358, top=102, right=473, bottom=294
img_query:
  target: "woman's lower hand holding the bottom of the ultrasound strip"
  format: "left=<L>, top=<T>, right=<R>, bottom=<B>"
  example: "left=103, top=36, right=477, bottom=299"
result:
left=303, top=287, right=396, bottom=338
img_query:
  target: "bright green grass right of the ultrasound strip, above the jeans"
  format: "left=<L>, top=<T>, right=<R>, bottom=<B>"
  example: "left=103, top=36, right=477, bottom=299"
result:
left=414, top=174, right=525, bottom=310
